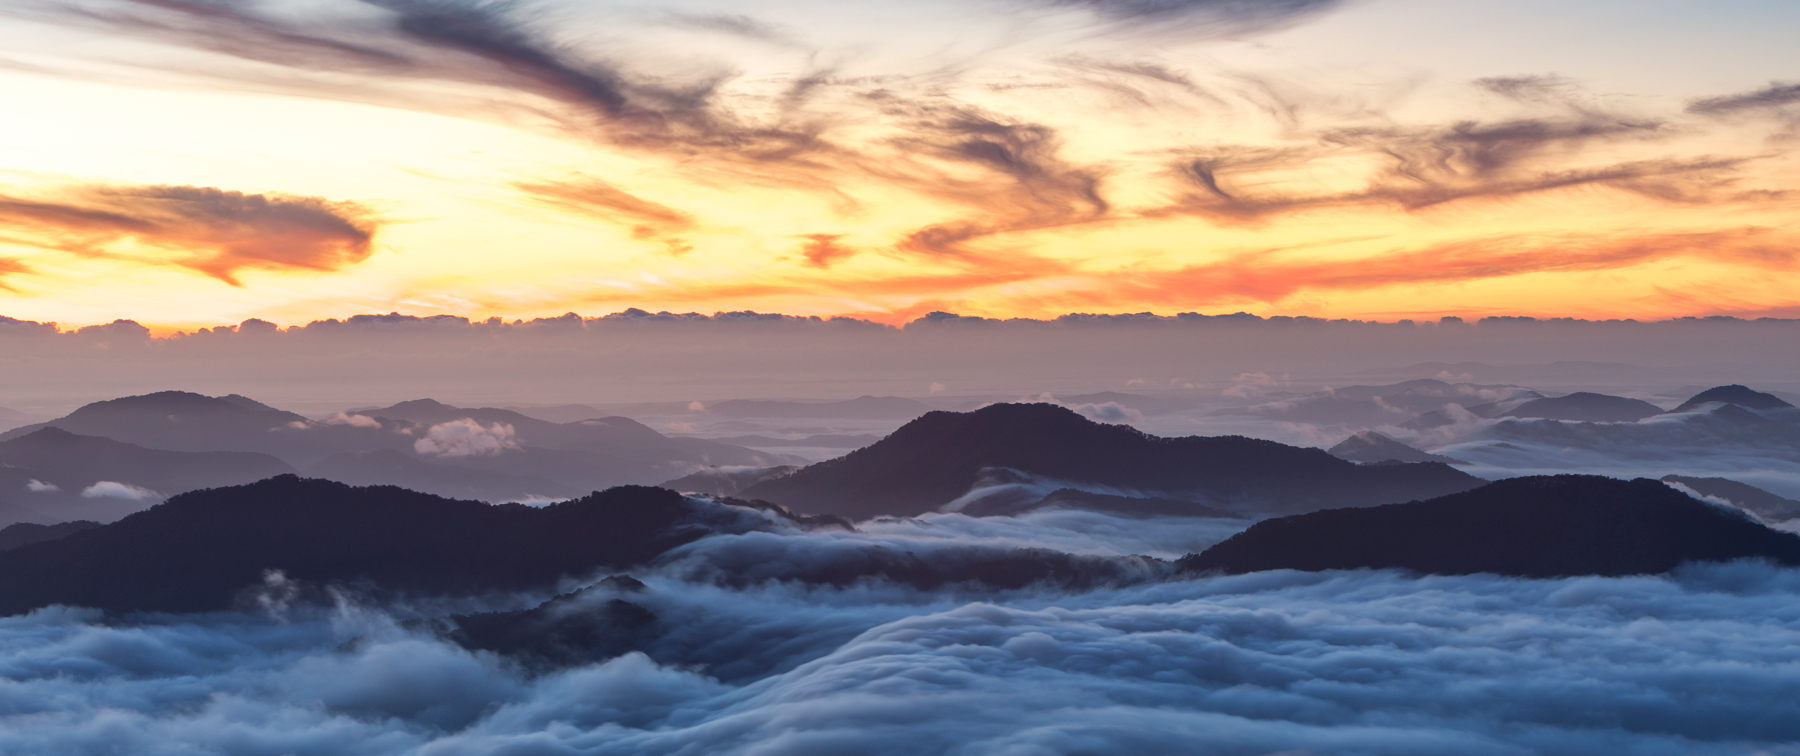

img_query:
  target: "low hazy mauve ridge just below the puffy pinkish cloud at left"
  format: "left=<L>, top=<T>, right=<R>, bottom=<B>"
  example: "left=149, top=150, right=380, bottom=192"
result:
left=306, top=448, right=581, bottom=502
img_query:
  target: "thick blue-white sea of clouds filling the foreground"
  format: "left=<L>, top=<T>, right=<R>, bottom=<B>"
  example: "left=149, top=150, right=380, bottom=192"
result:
left=0, top=511, right=1800, bottom=756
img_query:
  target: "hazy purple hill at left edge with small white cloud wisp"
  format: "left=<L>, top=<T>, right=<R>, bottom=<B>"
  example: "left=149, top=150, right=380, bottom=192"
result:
left=0, top=428, right=293, bottom=522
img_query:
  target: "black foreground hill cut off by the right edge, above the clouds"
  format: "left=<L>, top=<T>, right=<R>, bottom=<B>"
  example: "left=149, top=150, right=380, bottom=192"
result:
left=1179, top=475, right=1800, bottom=578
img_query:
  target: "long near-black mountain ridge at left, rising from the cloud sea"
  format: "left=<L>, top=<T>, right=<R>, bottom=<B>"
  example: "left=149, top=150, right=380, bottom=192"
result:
left=0, top=475, right=795, bottom=614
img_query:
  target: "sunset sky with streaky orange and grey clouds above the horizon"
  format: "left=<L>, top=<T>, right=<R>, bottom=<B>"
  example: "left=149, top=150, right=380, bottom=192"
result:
left=0, top=0, right=1800, bottom=331
